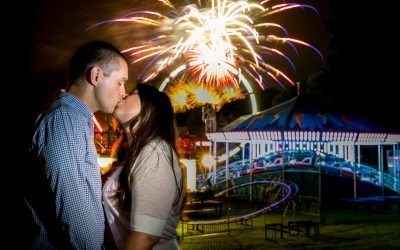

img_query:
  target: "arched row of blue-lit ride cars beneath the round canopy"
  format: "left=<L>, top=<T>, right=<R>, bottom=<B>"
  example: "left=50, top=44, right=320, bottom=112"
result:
left=209, top=150, right=396, bottom=190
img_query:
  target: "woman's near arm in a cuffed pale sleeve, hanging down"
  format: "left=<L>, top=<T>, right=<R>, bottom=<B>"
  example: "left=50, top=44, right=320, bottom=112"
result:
left=125, top=141, right=177, bottom=249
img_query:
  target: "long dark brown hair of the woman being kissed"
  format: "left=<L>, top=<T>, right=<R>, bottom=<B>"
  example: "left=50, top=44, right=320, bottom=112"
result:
left=117, top=83, right=183, bottom=209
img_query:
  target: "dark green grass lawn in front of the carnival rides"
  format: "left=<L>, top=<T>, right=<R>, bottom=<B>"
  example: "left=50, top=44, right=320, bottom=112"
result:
left=180, top=207, right=400, bottom=250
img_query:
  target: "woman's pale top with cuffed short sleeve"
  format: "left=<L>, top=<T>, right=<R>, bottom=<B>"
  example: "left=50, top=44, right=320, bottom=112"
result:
left=103, top=139, right=184, bottom=249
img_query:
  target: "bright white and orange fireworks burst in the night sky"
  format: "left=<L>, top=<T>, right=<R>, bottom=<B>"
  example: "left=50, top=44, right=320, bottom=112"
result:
left=89, top=0, right=322, bottom=111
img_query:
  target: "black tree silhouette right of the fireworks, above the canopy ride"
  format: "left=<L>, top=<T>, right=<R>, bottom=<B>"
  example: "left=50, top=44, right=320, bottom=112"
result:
left=304, top=0, right=400, bottom=131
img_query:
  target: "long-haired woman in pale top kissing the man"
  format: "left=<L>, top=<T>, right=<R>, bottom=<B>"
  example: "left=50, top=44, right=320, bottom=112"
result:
left=103, top=83, right=184, bottom=249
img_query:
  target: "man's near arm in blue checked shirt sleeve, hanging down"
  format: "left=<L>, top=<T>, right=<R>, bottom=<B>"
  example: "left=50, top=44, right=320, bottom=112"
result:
left=42, top=113, right=103, bottom=249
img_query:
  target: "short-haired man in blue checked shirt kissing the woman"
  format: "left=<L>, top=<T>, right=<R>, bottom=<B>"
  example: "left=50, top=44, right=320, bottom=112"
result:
left=23, top=41, right=128, bottom=249
